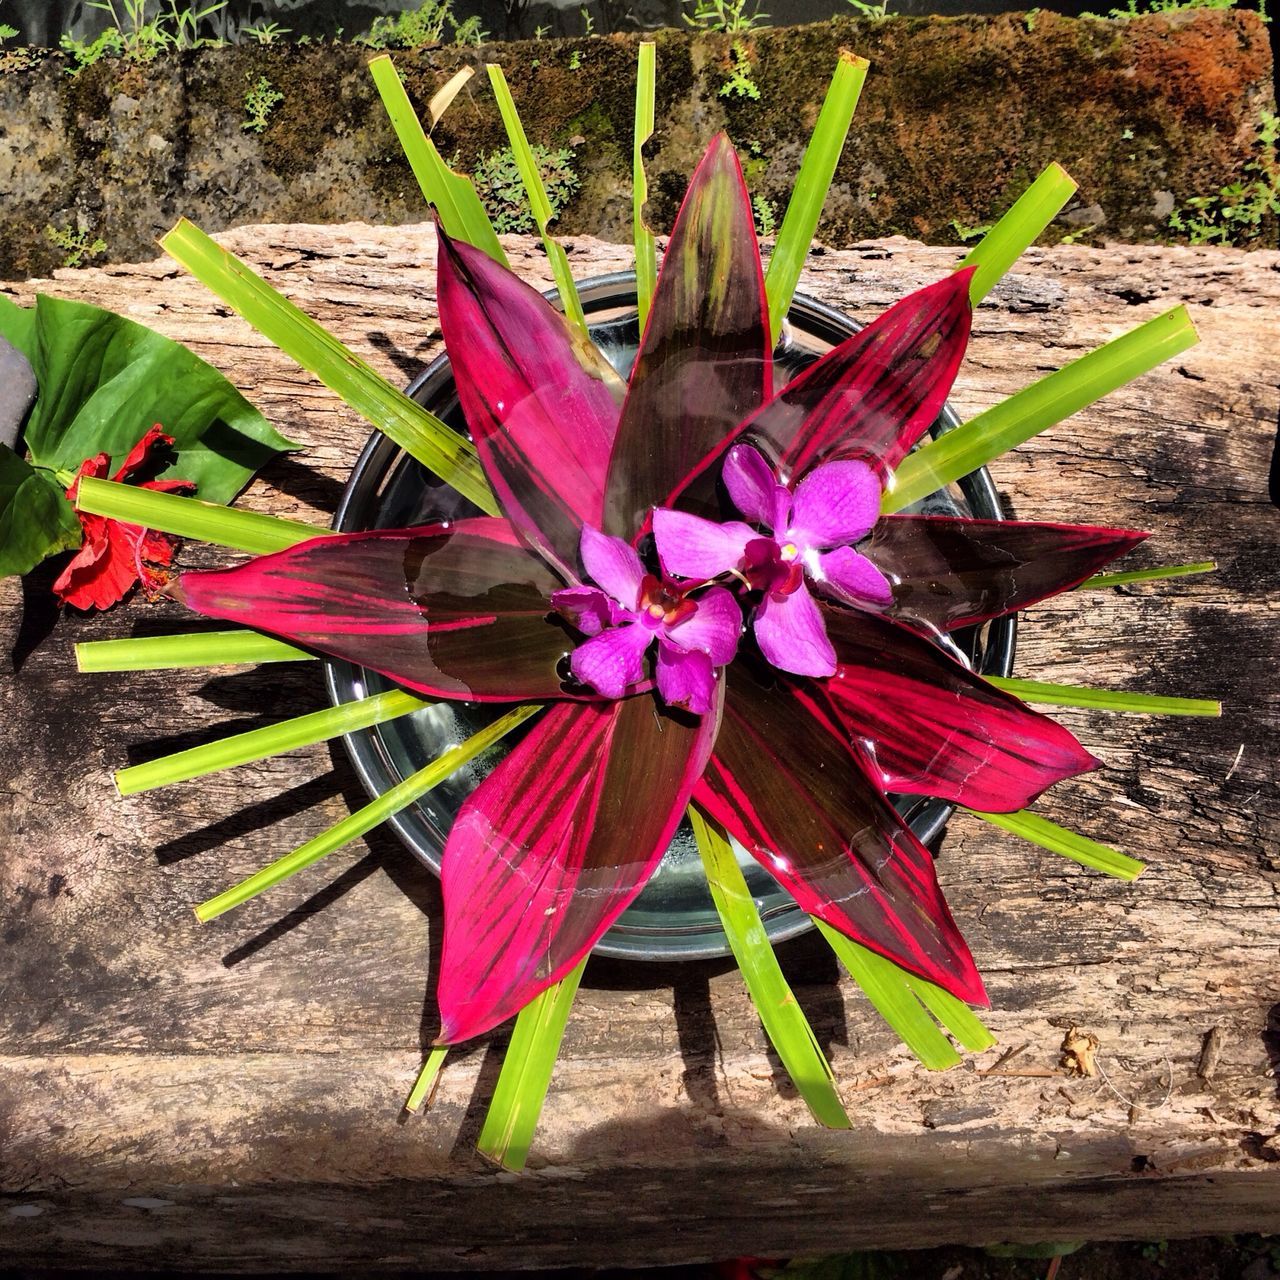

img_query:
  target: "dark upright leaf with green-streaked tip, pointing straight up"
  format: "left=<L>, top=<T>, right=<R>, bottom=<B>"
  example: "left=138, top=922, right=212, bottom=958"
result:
left=604, top=133, right=772, bottom=538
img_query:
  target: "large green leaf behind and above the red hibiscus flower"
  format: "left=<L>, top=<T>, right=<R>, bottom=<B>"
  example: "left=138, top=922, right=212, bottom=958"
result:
left=0, top=294, right=297, bottom=503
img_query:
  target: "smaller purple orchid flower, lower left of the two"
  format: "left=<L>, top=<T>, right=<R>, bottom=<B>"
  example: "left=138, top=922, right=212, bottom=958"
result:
left=552, top=525, right=742, bottom=716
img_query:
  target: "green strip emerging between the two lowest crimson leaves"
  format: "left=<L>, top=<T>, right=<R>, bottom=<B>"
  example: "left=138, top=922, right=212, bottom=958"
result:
left=689, top=808, right=850, bottom=1129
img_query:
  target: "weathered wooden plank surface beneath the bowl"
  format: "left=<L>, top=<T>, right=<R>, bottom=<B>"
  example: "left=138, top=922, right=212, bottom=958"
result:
left=0, top=225, right=1280, bottom=1271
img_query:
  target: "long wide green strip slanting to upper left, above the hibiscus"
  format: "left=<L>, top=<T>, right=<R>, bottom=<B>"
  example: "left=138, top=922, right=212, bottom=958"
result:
left=160, top=219, right=498, bottom=516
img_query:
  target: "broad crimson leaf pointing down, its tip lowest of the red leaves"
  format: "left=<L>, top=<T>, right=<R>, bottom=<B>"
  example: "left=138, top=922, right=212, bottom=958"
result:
left=439, top=696, right=719, bottom=1043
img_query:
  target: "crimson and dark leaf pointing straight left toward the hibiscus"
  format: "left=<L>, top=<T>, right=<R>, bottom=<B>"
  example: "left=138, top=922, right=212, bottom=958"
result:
left=178, top=518, right=572, bottom=701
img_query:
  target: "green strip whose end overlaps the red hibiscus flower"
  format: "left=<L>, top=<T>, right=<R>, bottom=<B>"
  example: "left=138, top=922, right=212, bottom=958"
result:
left=76, top=476, right=322, bottom=556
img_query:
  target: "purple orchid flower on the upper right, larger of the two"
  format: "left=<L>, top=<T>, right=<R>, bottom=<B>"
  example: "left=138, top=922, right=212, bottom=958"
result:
left=653, top=444, right=893, bottom=676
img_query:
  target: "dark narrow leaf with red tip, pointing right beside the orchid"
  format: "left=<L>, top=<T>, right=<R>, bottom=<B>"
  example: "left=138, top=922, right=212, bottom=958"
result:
left=863, top=516, right=1147, bottom=631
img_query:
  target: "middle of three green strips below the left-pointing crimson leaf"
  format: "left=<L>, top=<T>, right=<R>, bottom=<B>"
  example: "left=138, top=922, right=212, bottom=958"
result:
left=115, top=689, right=429, bottom=796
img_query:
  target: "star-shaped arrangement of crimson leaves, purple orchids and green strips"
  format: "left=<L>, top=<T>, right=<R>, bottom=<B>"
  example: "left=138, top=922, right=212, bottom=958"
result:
left=78, top=46, right=1215, bottom=1167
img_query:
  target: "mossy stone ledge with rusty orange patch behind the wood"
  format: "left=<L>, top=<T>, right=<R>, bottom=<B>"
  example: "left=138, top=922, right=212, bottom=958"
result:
left=0, top=10, right=1275, bottom=278
